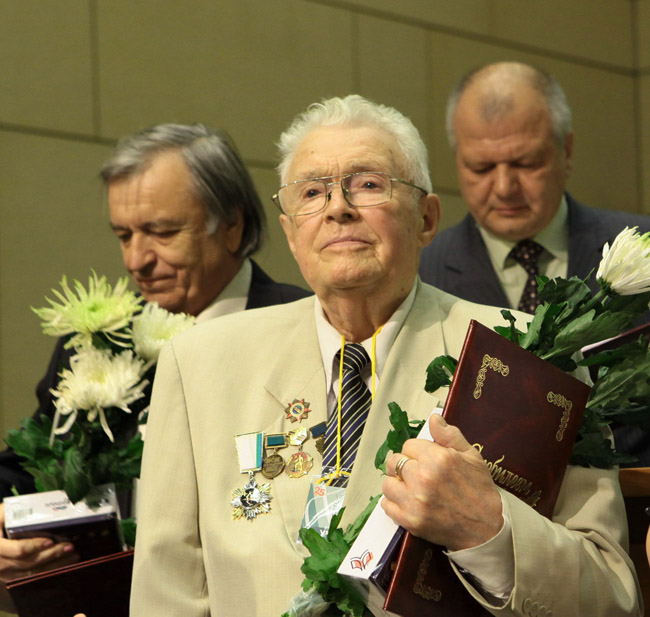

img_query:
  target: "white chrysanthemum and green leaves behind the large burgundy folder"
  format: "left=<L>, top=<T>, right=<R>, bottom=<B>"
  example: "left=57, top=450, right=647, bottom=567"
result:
left=422, top=228, right=650, bottom=468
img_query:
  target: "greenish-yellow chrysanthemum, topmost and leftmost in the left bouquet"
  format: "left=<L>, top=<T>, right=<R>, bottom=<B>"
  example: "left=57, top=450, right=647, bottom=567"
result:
left=32, top=271, right=140, bottom=348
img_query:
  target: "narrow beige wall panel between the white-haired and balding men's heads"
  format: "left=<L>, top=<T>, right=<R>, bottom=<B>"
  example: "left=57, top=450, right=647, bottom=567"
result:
left=358, top=17, right=431, bottom=170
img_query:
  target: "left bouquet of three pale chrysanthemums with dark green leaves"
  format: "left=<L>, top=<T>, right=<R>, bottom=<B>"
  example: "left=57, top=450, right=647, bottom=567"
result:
left=7, top=272, right=194, bottom=503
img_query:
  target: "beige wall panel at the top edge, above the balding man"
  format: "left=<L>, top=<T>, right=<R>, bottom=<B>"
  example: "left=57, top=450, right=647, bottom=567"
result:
left=491, top=0, right=634, bottom=68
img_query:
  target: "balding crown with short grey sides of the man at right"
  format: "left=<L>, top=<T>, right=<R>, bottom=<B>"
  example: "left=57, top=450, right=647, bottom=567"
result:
left=446, top=62, right=572, bottom=150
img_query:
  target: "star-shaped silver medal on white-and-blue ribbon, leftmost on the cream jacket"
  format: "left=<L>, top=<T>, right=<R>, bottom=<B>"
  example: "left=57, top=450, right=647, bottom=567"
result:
left=230, top=432, right=273, bottom=521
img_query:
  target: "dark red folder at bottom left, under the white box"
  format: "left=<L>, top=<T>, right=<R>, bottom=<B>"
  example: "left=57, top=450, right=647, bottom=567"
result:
left=7, top=549, right=133, bottom=617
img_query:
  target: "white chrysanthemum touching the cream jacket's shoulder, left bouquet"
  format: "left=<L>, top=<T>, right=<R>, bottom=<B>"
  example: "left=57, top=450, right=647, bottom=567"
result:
left=133, top=302, right=196, bottom=363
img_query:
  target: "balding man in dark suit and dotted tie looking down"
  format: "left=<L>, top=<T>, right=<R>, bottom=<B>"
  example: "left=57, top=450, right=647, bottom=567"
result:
left=419, top=62, right=650, bottom=465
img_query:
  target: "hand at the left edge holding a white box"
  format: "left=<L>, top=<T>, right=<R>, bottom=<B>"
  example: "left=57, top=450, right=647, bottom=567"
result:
left=0, top=504, right=78, bottom=583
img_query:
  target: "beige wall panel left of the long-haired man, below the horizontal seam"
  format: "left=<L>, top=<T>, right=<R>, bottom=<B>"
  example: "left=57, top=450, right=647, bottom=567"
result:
left=0, top=132, right=124, bottom=439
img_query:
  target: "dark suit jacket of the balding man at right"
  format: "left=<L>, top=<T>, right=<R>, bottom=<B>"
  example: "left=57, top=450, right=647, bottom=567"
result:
left=420, top=193, right=650, bottom=466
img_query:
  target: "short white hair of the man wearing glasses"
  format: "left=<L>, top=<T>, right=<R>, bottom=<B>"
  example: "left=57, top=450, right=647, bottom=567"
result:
left=277, top=94, right=432, bottom=193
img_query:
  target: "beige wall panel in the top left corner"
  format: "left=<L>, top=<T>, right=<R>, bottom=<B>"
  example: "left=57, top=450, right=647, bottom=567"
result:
left=0, top=0, right=93, bottom=133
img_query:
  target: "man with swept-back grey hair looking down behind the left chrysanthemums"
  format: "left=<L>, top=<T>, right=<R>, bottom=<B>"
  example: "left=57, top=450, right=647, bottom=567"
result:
left=0, top=124, right=309, bottom=595
